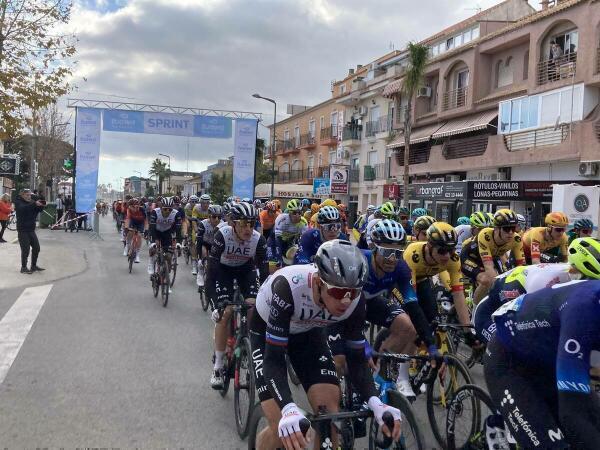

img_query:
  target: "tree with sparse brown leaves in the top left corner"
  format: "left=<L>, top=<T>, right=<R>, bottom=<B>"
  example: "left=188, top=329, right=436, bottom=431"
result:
left=0, top=0, right=75, bottom=141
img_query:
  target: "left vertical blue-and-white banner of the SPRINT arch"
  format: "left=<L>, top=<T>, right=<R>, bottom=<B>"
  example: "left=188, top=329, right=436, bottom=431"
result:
left=75, top=108, right=101, bottom=212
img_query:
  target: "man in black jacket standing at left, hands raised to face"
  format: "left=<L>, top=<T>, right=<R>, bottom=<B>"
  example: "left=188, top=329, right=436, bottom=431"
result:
left=15, top=189, right=45, bottom=274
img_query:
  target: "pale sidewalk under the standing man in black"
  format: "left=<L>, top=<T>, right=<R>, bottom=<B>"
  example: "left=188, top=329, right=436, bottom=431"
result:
left=0, top=228, right=90, bottom=290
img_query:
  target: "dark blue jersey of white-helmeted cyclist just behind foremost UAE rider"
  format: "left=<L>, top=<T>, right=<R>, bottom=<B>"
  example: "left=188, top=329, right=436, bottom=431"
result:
left=362, top=250, right=417, bottom=303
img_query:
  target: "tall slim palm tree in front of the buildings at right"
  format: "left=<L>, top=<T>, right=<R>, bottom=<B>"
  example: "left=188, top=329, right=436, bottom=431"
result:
left=402, top=42, right=429, bottom=206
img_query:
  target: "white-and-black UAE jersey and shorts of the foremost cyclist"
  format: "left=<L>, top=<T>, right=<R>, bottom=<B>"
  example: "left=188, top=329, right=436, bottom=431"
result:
left=250, top=264, right=376, bottom=407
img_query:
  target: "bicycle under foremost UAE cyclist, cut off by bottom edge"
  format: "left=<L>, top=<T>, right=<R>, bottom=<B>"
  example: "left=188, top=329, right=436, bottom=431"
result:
left=248, top=403, right=394, bottom=450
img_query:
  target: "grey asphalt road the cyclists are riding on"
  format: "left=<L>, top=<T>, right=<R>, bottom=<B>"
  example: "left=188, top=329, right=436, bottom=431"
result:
left=0, top=217, right=480, bottom=449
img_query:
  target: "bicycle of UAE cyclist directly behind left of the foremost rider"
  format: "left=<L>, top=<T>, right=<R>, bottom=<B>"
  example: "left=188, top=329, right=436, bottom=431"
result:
left=213, top=280, right=256, bottom=439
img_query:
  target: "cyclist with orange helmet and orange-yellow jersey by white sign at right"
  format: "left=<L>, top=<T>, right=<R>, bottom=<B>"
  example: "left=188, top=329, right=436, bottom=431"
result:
left=523, top=212, right=569, bottom=264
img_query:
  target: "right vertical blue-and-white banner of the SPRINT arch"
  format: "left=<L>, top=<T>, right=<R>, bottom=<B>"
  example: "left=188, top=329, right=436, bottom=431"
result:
left=233, top=119, right=258, bottom=198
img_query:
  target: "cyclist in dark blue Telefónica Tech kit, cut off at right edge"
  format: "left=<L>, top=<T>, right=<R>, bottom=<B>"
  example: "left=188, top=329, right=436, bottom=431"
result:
left=484, top=280, right=600, bottom=449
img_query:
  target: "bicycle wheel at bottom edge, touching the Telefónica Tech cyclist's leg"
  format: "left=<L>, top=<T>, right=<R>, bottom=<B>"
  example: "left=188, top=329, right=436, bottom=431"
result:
left=446, top=384, right=497, bottom=450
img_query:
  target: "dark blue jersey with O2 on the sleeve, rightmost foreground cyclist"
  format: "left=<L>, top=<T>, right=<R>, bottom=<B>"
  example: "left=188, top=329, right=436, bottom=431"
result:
left=493, top=280, right=600, bottom=394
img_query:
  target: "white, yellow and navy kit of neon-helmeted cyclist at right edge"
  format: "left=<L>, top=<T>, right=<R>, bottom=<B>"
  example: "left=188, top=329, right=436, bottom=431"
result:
left=473, top=263, right=571, bottom=343
